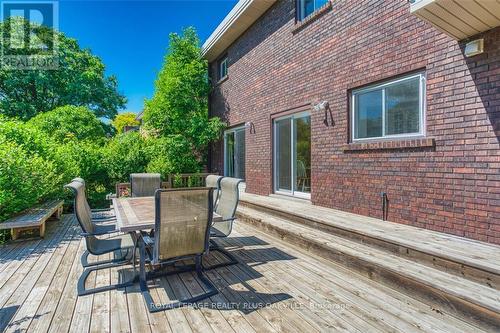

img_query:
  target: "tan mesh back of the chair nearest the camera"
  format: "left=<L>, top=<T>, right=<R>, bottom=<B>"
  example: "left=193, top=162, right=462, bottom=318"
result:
left=153, top=187, right=213, bottom=263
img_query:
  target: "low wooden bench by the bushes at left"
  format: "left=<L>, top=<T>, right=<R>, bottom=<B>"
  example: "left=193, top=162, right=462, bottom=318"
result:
left=0, top=200, right=63, bottom=240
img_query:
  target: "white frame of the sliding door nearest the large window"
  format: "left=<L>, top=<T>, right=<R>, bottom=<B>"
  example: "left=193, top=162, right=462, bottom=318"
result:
left=273, top=111, right=312, bottom=200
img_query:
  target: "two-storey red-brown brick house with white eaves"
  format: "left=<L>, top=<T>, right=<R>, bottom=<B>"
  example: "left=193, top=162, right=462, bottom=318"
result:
left=203, top=0, right=500, bottom=244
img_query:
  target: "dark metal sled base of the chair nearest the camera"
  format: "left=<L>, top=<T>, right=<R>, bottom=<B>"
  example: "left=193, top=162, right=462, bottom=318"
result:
left=139, top=249, right=219, bottom=312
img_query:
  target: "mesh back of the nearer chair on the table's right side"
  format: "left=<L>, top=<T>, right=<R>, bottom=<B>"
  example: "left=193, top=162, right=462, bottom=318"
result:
left=212, top=177, right=243, bottom=236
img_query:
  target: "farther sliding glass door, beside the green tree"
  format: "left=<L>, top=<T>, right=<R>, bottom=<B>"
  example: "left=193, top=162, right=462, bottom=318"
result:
left=224, top=127, right=245, bottom=179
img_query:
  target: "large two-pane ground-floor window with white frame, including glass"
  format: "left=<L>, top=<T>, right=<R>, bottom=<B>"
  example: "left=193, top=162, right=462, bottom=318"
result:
left=351, top=73, right=425, bottom=141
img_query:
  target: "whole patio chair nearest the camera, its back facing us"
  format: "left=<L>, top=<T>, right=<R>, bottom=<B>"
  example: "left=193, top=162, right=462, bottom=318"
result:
left=139, top=187, right=218, bottom=312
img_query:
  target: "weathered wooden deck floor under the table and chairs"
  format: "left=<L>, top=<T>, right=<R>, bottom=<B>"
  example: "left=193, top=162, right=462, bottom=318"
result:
left=0, top=216, right=488, bottom=333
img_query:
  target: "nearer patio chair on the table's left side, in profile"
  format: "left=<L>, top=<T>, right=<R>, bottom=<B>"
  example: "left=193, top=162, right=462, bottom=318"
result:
left=64, top=181, right=136, bottom=296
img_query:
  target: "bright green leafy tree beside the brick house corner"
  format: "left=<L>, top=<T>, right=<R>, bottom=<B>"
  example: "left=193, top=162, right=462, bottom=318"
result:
left=143, top=27, right=224, bottom=172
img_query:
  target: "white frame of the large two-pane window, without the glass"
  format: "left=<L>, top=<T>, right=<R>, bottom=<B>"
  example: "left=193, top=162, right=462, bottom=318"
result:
left=351, top=72, right=426, bottom=142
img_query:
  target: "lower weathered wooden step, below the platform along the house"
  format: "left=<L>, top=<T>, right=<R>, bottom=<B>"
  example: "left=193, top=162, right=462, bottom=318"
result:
left=237, top=205, right=500, bottom=331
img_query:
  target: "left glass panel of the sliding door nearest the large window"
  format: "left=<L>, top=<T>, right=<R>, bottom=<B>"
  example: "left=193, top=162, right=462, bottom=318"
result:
left=275, top=118, right=292, bottom=191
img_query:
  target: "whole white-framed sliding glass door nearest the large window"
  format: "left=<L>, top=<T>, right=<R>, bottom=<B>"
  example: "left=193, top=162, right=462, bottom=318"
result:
left=274, top=113, right=311, bottom=198
